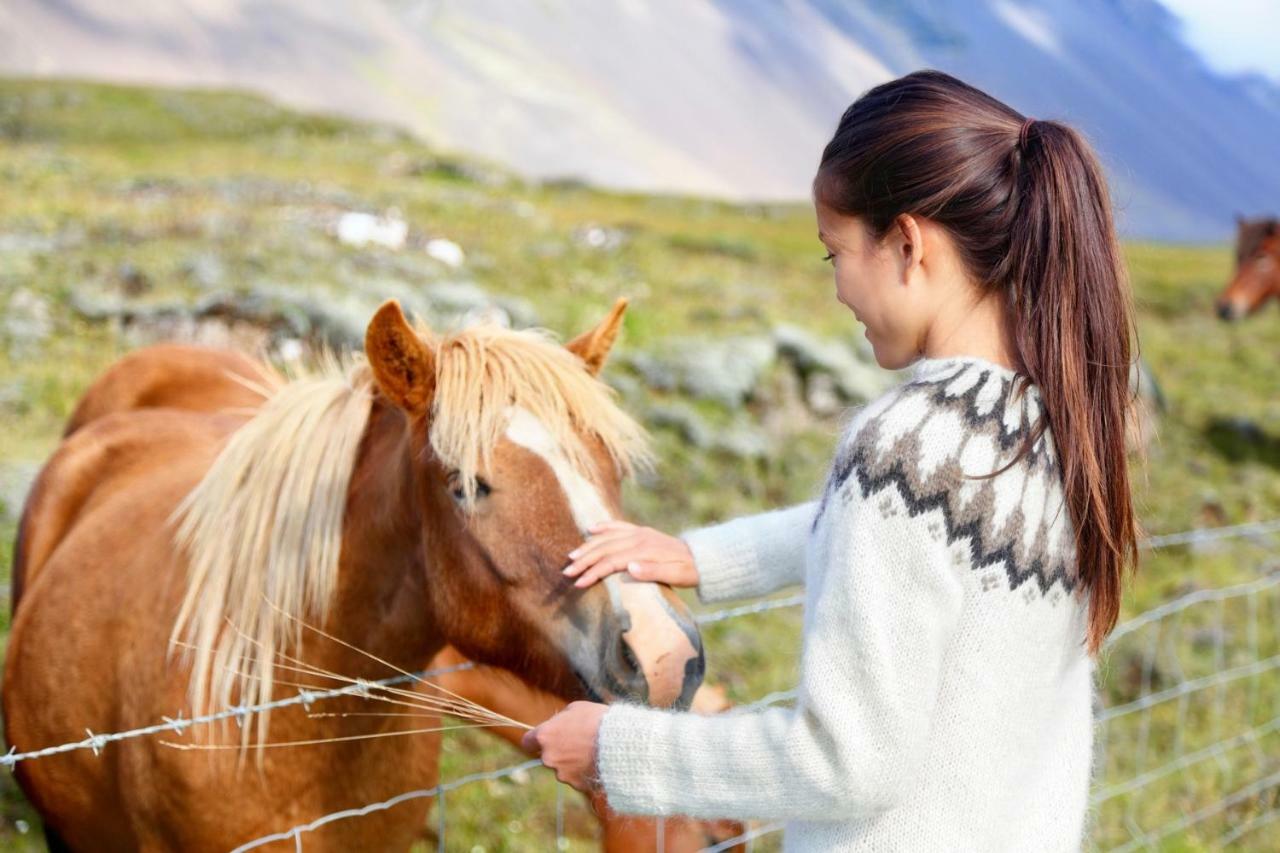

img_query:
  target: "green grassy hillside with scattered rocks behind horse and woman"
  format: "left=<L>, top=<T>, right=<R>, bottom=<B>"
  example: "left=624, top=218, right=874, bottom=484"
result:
left=0, top=81, right=1280, bottom=849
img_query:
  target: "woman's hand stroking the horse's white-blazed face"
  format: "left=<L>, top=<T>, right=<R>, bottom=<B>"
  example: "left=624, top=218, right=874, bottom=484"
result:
left=564, top=521, right=698, bottom=588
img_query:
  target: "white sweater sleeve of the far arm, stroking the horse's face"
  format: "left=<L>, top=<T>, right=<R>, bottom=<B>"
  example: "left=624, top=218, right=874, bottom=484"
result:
left=680, top=501, right=818, bottom=605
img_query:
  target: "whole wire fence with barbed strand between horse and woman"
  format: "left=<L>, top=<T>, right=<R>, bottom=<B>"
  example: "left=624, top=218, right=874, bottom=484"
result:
left=0, top=520, right=1280, bottom=853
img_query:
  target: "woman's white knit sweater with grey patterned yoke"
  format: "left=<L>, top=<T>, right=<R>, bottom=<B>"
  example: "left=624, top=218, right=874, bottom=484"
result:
left=598, top=356, right=1093, bottom=852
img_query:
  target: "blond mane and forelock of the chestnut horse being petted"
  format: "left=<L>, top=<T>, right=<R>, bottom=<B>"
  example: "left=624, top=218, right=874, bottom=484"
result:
left=170, top=324, right=650, bottom=745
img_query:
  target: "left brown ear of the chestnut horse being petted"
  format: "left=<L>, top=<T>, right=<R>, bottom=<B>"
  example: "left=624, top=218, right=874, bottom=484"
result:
left=365, top=300, right=435, bottom=415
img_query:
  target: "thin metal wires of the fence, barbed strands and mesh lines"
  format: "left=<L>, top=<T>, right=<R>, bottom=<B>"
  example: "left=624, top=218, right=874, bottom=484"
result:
left=0, top=519, right=1280, bottom=853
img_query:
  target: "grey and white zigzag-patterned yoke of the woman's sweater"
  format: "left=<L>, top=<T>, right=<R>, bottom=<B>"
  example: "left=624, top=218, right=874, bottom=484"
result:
left=814, top=359, right=1076, bottom=594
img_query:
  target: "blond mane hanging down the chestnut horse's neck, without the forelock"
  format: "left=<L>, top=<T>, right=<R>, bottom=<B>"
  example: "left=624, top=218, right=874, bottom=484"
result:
left=170, top=356, right=374, bottom=743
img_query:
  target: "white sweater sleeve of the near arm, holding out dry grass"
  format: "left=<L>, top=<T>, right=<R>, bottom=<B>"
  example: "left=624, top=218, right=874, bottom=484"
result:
left=596, top=478, right=963, bottom=820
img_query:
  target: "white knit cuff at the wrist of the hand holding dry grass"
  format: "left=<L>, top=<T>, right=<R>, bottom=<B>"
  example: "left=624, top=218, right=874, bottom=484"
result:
left=595, top=703, right=671, bottom=815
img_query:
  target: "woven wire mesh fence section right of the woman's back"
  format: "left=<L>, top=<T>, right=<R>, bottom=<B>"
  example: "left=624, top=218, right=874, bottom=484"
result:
left=1092, top=564, right=1280, bottom=852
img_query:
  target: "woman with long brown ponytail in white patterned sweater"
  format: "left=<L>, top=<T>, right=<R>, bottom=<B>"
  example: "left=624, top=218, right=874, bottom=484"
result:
left=526, top=72, right=1137, bottom=850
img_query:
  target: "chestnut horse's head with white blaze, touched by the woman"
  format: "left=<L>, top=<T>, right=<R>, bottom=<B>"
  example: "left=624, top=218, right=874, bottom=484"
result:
left=365, top=301, right=704, bottom=707
